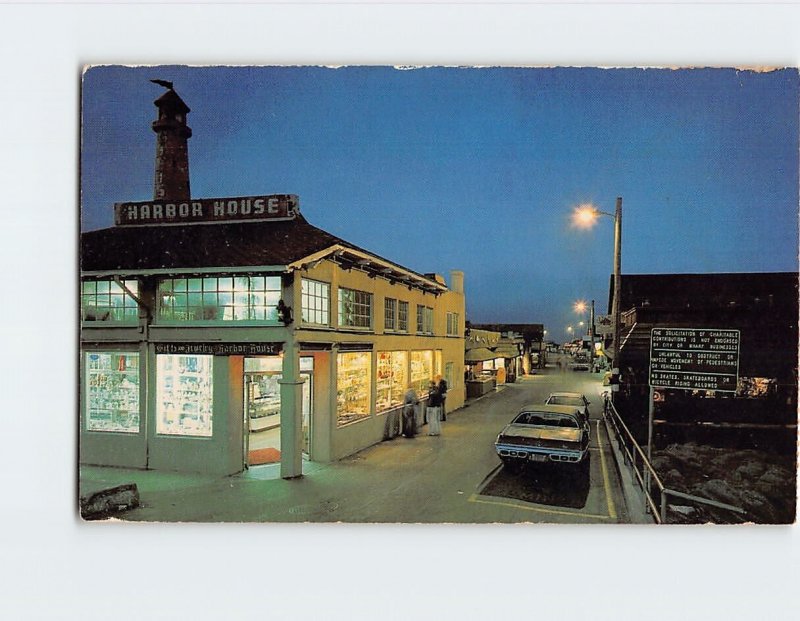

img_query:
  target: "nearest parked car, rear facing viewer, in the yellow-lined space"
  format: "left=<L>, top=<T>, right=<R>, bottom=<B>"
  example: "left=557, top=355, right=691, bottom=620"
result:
left=494, top=404, right=589, bottom=469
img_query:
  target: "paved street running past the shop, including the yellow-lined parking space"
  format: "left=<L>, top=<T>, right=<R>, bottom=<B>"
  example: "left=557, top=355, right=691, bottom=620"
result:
left=81, top=370, right=628, bottom=523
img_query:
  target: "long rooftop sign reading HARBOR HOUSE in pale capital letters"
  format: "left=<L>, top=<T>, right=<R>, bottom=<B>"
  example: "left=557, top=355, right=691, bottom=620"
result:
left=114, top=194, right=300, bottom=226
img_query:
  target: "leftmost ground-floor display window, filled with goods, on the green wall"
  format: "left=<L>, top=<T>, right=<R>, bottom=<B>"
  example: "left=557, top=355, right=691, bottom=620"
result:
left=85, top=352, right=139, bottom=433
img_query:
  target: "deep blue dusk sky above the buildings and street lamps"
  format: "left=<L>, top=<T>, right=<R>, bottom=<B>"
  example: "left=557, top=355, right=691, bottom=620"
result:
left=81, top=67, right=798, bottom=340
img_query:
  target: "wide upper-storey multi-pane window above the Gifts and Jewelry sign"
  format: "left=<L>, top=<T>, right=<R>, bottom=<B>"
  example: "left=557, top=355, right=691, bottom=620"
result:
left=158, top=276, right=281, bottom=323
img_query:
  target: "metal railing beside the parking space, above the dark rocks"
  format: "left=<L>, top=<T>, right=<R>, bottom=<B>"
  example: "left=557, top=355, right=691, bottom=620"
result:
left=603, top=393, right=746, bottom=524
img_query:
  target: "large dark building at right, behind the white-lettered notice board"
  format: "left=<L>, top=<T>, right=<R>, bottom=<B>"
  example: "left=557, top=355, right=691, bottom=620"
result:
left=609, top=272, right=798, bottom=450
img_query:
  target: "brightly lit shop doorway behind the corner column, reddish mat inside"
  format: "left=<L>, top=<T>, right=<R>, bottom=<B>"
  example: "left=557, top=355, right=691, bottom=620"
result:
left=244, top=356, right=314, bottom=466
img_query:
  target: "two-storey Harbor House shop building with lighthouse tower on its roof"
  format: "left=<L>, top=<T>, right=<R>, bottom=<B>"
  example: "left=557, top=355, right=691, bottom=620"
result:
left=80, top=89, right=465, bottom=478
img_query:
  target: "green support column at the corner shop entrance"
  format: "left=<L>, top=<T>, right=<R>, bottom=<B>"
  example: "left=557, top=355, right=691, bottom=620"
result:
left=278, top=341, right=303, bottom=479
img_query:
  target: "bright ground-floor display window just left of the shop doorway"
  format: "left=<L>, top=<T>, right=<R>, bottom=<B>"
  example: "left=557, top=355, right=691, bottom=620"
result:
left=156, top=354, right=214, bottom=437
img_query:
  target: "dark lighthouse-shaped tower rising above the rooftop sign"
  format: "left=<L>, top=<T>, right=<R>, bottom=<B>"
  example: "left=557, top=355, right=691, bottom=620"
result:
left=153, top=88, right=192, bottom=201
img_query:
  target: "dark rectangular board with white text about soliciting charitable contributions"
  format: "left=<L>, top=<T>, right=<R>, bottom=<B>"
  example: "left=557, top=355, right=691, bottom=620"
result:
left=650, top=328, right=739, bottom=392
